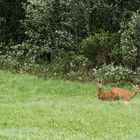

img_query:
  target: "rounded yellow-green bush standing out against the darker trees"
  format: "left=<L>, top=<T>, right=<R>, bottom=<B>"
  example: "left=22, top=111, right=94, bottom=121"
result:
left=82, top=32, right=119, bottom=66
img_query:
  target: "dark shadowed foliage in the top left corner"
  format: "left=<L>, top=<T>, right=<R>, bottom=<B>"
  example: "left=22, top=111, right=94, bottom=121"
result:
left=0, top=0, right=27, bottom=44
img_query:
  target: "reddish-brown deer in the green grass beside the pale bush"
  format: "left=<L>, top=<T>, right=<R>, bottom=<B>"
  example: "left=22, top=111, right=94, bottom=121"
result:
left=97, top=81, right=140, bottom=101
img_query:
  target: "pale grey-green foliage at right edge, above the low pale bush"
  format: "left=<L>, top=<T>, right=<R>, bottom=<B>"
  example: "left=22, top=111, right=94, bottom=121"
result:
left=121, top=12, right=140, bottom=69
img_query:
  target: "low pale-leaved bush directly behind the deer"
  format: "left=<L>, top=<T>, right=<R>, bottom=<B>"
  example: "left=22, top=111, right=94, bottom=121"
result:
left=95, top=64, right=137, bottom=83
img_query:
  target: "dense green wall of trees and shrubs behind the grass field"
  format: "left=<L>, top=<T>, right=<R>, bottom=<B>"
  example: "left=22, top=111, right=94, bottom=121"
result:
left=0, top=0, right=140, bottom=83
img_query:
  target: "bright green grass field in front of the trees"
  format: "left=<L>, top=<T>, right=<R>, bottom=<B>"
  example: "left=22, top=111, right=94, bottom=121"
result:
left=0, top=71, right=140, bottom=140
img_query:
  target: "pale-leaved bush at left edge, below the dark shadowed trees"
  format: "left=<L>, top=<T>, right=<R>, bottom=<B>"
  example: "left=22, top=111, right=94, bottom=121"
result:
left=0, top=43, right=41, bottom=72
